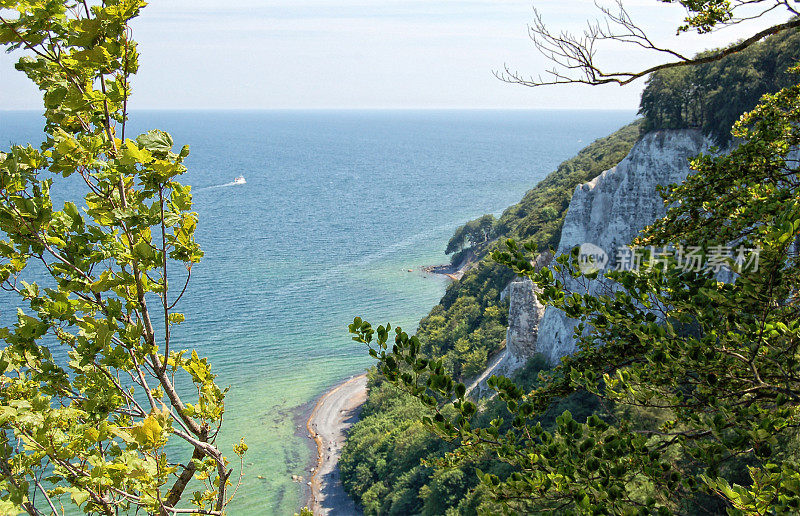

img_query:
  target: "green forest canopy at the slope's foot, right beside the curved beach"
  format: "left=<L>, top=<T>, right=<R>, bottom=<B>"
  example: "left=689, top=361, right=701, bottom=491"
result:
left=339, top=359, right=547, bottom=515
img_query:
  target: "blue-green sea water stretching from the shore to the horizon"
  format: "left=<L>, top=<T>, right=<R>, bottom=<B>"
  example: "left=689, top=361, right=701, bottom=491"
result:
left=0, top=111, right=634, bottom=515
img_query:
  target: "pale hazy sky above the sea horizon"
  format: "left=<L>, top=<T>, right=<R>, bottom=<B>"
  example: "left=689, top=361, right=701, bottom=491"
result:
left=0, top=0, right=785, bottom=110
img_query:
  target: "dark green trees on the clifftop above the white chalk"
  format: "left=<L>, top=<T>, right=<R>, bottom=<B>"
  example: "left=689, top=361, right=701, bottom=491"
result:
left=639, top=31, right=800, bottom=144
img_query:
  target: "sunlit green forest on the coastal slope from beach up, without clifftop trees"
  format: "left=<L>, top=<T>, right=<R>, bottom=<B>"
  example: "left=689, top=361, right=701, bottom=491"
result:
left=340, top=122, right=639, bottom=514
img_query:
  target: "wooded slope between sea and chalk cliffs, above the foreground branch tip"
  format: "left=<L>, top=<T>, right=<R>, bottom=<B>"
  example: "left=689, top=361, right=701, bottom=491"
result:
left=417, top=122, right=639, bottom=377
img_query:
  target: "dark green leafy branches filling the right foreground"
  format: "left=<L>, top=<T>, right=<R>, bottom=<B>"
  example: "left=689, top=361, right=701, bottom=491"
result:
left=350, top=70, right=800, bottom=514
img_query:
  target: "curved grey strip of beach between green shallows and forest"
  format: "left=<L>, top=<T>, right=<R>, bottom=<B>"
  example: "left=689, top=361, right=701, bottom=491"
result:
left=306, top=373, right=367, bottom=515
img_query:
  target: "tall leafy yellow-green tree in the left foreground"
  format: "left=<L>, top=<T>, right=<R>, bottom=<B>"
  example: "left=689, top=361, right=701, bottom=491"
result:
left=0, top=0, right=246, bottom=515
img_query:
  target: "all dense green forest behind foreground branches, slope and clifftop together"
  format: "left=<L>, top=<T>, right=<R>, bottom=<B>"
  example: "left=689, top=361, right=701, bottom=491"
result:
left=340, top=28, right=800, bottom=514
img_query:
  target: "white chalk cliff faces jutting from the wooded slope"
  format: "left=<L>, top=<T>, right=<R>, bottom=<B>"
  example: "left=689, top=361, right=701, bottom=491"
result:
left=504, top=130, right=712, bottom=369
